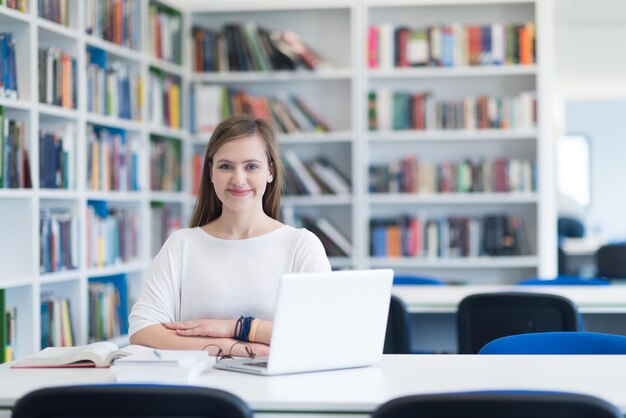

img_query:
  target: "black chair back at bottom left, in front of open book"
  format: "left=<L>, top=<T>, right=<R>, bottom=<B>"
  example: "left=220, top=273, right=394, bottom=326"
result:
left=12, top=384, right=252, bottom=418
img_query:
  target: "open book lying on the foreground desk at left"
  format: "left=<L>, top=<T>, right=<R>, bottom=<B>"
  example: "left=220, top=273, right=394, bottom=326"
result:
left=11, top=341, right=154, bottom=368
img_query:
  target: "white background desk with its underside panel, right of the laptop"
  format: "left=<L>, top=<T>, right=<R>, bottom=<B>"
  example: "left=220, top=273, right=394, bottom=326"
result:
left=393, top=284, right=626, bottom=353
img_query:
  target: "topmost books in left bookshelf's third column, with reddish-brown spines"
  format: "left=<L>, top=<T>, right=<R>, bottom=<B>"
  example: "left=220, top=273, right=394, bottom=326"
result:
left=85, top=0, right=142, bottom=49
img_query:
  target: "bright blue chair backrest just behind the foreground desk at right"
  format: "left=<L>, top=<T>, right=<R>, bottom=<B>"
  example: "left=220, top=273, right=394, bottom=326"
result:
left=479, top=332, right=626, bottom=354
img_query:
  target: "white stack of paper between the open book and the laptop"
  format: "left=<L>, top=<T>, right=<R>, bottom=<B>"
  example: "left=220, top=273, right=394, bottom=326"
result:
left=111, top=350, right=215, bottom=383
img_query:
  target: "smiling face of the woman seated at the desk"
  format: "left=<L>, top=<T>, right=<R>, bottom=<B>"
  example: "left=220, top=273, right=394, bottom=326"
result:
left=211, top=135, right=273, bottom=213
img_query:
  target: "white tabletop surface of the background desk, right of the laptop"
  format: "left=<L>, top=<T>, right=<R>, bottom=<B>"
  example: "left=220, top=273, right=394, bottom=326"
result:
left=393, top=285, right=626, bottom=313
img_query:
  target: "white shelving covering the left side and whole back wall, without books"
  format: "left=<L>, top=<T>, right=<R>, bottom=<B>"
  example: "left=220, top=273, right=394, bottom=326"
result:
left=0, top=0, right=556, bottom=357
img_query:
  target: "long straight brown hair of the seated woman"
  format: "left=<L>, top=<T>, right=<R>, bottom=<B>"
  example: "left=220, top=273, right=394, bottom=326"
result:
left=189, top=116, right=284, bottom=228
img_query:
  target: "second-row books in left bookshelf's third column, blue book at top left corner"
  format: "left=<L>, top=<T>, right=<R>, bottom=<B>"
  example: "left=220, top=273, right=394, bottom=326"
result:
left=87, top=47, right=143, bottom=120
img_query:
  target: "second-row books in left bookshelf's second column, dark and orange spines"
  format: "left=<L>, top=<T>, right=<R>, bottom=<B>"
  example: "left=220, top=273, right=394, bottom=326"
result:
left=38, top=47, right=78, bottom=109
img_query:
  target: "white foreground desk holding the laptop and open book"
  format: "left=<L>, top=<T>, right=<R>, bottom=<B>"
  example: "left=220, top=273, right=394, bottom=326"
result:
left=0, top=355, right=626, bottom=418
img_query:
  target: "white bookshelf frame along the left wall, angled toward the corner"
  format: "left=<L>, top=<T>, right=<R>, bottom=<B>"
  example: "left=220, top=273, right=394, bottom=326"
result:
left=0, top=0, right=191, bottom=358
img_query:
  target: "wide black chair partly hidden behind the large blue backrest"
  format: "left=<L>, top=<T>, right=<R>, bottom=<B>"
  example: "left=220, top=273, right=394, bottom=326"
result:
left=457, top=292, right=581, bottom=354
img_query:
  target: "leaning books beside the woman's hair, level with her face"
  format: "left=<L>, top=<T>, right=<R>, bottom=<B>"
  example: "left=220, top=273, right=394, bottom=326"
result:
left=283, top=149, right=351, bottom=196
